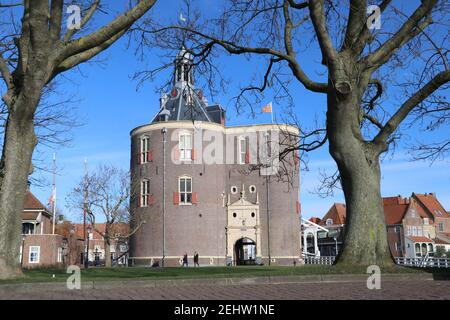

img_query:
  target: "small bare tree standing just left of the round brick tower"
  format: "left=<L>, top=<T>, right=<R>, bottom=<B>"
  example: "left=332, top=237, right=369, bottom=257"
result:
left=67, top=165, right=145, bottom=267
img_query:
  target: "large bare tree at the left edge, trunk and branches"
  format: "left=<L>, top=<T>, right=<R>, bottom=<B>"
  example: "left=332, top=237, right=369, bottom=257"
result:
left=0, top=0, right=156, bottom=278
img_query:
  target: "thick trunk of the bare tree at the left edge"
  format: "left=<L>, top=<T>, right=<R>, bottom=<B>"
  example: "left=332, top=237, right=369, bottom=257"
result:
left=0, top=100, right=39, bottom=279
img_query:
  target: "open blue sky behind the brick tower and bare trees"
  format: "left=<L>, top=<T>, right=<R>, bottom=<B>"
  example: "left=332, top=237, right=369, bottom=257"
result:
left=32, top=1, right=450, bottom=219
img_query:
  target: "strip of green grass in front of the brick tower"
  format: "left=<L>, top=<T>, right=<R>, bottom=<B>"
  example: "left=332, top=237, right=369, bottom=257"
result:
left=0, top=265, right=442, bottom=284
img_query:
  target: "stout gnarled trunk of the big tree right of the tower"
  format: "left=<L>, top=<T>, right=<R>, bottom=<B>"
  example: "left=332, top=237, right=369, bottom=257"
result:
left=327, top=88, right=393, bottom=267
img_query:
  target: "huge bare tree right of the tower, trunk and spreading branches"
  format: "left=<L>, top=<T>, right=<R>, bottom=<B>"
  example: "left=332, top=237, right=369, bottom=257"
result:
left=139, top=0, right=450, bottom=266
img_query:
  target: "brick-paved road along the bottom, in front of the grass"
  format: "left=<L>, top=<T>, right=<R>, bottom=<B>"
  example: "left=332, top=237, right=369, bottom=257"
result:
left=0, top=280, right=450, bottom=300
